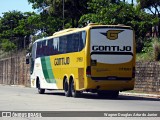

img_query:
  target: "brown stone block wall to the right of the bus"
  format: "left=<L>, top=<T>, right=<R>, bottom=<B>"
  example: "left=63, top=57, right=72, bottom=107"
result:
left=135, top=62, right=160, bottom=94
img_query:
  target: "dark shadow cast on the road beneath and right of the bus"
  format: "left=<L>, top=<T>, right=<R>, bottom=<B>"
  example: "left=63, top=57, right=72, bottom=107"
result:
left=44, top=92, right=160, bottom=101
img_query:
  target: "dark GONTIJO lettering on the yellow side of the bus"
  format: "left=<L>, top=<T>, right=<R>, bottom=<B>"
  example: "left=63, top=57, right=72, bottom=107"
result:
left=54, top=57, right=70, bottom=66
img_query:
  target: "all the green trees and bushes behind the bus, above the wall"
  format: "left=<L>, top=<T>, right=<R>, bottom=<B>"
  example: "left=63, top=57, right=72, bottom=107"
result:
left=0, top=0, right=160, bottom=61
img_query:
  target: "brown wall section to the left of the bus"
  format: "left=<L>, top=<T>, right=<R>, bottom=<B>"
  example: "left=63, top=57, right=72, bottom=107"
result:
left=0, top=52, right=30, bottom=86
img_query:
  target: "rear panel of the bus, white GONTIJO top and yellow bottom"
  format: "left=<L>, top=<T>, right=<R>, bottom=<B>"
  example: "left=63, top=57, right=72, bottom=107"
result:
left=90, top=27, right=134, bottom=80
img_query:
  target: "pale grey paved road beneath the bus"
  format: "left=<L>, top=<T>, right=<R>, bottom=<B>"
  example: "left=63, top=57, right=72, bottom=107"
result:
left=0, top=85, right=160, bottom=120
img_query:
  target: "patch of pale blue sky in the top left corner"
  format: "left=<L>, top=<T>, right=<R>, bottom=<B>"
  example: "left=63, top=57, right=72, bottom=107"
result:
left=0, top=0, right=34, bottom=17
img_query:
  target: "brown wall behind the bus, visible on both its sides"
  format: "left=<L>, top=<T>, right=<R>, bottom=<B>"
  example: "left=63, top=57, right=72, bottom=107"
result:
left=0, top=52, right=160, bottom=94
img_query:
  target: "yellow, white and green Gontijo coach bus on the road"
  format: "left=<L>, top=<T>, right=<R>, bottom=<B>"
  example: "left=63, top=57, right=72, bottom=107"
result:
left=26, top=23, right=136, bottom=98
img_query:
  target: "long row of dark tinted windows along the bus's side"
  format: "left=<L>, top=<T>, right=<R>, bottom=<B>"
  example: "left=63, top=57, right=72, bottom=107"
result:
left=36, top=31, right=86, bottom=58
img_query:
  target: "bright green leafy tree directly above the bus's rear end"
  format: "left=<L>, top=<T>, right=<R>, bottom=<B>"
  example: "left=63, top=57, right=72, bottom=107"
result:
left=79, top=0, right=156, bottom=52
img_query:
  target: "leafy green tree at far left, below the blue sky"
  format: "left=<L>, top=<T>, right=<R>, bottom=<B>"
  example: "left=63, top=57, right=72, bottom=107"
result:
left=0, top=11, right=39, bottom=51
